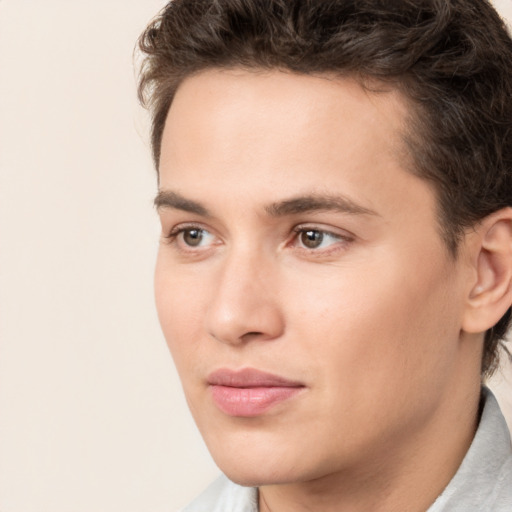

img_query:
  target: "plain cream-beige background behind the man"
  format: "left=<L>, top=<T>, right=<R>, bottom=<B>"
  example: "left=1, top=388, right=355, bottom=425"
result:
left=0, top=0, right=512, bottom=512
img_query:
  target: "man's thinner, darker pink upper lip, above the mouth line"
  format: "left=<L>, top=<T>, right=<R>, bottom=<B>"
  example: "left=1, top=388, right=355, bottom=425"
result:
left=207, top=368, right=304, bottom=388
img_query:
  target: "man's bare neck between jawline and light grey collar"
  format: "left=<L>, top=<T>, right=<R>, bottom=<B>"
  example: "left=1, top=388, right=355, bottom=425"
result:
left=259, top=382, right=480, bottom=512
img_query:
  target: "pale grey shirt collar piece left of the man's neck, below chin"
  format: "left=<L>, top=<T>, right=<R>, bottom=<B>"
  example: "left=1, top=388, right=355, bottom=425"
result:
left=180, top=476, right=258, bottom=512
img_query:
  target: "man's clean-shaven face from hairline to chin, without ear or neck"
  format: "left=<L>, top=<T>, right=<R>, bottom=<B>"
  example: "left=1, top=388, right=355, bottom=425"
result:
left=156, top=70, right=472, bottom=485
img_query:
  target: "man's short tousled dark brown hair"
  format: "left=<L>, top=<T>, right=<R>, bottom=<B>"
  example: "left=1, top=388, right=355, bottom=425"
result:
left=139, top=0, right=512, bottom=375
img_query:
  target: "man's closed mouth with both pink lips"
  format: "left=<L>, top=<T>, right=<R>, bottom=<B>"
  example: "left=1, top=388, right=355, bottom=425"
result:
left=207, top=368, right=305, bottom=417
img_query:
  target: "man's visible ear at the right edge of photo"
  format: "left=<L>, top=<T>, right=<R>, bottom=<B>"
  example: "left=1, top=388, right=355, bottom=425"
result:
left=462, top=208, right=512, bottom=333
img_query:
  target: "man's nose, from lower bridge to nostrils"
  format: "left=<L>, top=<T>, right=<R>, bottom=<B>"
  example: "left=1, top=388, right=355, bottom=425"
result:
left=206, top=250, right=285, bottom=345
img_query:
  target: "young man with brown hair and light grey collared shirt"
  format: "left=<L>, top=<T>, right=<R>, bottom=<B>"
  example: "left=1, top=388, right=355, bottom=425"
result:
left=140, top=0, right=512, bottom=512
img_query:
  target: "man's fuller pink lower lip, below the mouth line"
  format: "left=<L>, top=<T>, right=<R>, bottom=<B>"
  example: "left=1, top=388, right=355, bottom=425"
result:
left=210, top=386, right=303, bottom=417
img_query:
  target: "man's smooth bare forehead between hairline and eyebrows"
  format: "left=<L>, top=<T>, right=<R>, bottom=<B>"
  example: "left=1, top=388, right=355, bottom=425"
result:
left=160, top=69, right=427, bottom=222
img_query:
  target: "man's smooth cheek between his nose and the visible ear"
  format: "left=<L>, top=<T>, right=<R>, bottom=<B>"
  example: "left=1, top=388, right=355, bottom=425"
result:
left=285, top=250, right=458, bottom=382
